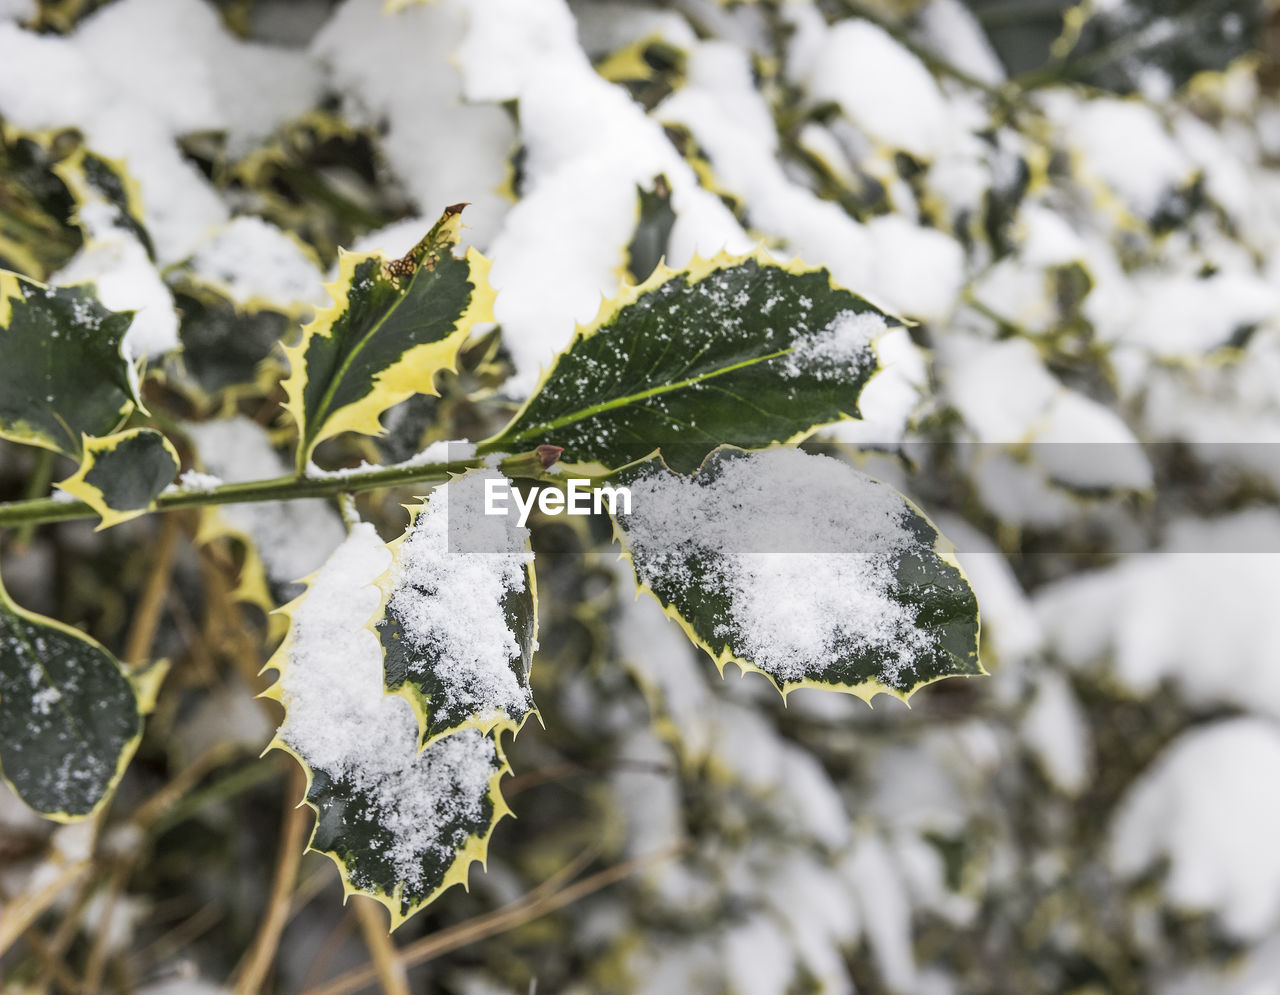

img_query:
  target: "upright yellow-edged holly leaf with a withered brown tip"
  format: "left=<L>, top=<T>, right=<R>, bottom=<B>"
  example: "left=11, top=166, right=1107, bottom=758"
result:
left=284, top=204, right=493, bottom=467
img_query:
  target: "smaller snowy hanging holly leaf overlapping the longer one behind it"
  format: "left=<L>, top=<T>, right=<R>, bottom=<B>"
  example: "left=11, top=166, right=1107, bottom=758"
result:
left=376, top=470, right=538, bottom=745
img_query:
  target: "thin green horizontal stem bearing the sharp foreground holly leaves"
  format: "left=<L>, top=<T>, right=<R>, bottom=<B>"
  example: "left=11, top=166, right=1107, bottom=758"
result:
left=0, top=456, right=488, bottom=528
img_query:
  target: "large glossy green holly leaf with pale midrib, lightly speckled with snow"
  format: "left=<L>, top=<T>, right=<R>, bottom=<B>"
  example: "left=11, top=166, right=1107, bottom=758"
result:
left=485, top=252, right=893, bottom=473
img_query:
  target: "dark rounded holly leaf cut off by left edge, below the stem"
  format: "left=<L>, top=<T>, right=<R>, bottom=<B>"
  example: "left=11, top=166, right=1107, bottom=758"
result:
left=0, top=571, right=141, bottom=822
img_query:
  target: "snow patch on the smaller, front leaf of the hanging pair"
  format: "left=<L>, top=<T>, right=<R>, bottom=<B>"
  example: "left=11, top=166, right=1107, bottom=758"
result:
left=388, top=470, right=532, bottom=717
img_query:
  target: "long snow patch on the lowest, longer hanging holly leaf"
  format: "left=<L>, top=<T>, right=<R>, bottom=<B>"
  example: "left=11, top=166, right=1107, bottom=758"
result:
left=280, top=522, right=498, bottom=889
